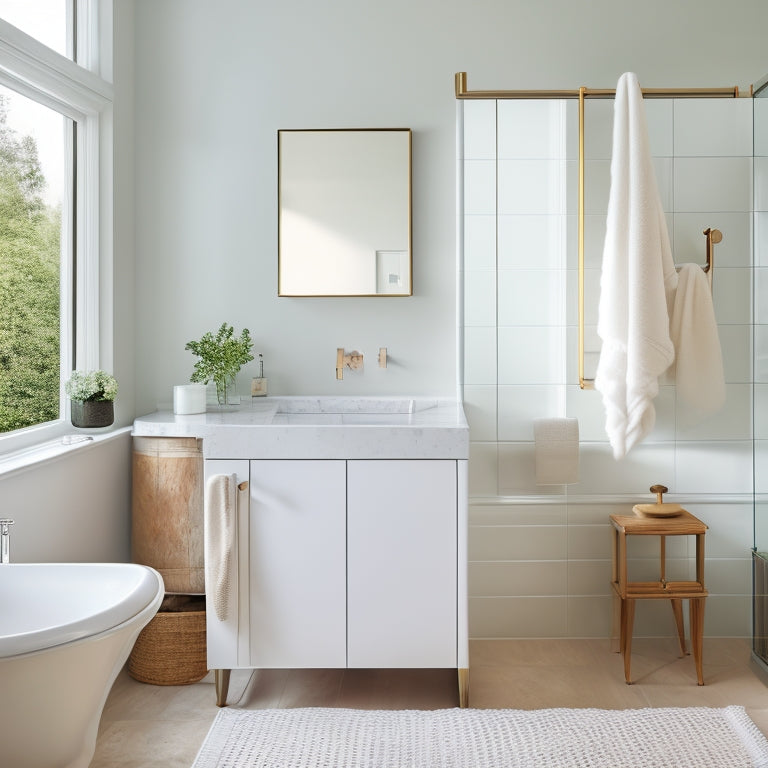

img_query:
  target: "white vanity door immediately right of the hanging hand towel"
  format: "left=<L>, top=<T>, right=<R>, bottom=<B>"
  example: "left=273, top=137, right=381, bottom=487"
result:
left=249, top=460, right=347, bottom=668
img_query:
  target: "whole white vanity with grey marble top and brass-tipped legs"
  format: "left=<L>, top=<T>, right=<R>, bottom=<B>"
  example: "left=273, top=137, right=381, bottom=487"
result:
left=134, top=397, right=469, bottom=706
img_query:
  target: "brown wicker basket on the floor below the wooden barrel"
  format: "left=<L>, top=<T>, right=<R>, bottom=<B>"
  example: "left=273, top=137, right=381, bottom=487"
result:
left=128, top=595, right=208, bottom=685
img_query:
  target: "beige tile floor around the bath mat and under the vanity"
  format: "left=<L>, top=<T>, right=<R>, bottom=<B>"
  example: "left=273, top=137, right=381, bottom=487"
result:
left=91, top=638, right=768, bottom=768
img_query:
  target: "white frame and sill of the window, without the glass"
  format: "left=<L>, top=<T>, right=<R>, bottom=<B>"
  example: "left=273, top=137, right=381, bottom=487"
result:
left=0, top=0, right=113, bottom=455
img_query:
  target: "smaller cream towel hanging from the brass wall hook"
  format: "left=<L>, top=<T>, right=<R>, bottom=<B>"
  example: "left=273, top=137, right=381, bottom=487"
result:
left=670, top=264, right=725, bottom=422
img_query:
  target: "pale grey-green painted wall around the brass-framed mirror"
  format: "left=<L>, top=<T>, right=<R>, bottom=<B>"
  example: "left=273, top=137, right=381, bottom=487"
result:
left=126, top=0, right=768, bottom=413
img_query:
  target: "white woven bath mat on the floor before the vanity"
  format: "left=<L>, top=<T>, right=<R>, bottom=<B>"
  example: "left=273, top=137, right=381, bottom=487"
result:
left=192, top=706, right=768, bottom=768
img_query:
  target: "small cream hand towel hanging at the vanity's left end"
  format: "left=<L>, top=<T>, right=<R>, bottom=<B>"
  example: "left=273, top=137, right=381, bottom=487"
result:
left=204, top=475, right=237, bottom=621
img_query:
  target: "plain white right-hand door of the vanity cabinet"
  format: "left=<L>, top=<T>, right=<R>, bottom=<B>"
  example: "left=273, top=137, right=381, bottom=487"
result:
left=347, top=460, right=457, bottom=667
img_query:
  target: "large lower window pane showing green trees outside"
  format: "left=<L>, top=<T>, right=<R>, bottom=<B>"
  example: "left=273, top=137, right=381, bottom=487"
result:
left=0, top=87, right=70, bottom=432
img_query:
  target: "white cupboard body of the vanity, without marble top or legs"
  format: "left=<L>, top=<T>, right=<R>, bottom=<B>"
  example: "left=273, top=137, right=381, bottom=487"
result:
left=206, top=459, right=459, bottom=668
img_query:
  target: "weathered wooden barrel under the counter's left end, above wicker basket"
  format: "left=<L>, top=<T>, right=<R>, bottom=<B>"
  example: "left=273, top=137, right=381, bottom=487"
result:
left=131, top=437, right=205, bottom=594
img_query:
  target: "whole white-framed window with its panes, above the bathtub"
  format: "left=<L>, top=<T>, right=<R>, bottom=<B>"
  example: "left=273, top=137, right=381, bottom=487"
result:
left=0, top=0, right=112, bottom=452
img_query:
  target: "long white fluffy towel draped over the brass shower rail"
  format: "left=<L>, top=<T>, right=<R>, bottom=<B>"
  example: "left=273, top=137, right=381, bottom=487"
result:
left=595, top=72, right=677, bottom=459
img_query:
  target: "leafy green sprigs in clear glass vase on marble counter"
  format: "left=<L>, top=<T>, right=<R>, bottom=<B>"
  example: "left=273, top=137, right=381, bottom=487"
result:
left=184, top=323, right=253, bottom=405
